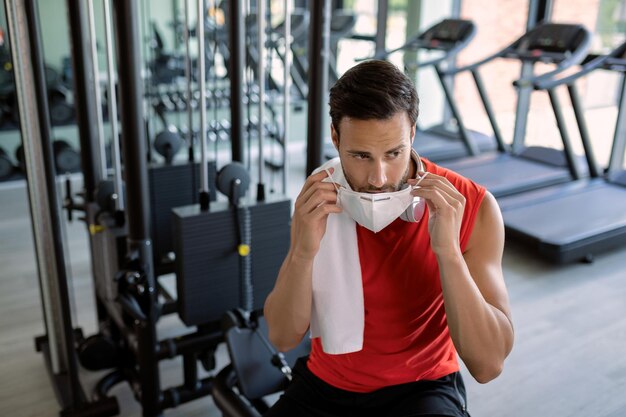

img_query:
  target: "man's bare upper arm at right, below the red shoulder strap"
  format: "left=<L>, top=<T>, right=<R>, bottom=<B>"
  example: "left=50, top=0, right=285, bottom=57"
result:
left=463, top=192, right=510, bottom=319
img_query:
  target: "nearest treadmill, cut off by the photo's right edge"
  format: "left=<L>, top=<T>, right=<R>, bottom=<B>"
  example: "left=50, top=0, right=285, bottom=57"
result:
left=499, top=42, right=626, bottom=263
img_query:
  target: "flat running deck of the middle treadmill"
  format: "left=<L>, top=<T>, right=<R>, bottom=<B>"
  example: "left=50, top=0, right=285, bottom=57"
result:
left=441, top=153, right=571, bottom=197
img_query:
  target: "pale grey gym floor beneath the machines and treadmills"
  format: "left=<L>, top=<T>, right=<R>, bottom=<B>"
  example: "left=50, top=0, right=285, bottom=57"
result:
left=0, top=140, right=626, bottom=417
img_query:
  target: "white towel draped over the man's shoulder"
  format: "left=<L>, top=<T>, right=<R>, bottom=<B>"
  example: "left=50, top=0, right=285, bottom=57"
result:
left=311, top=158, right=365, bottom=354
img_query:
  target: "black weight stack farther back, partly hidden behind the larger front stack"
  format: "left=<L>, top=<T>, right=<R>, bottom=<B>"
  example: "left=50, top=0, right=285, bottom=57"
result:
left=148, top=161, right=216, bottom=276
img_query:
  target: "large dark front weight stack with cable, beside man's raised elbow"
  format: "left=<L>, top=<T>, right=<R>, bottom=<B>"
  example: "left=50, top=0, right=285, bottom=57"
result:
left=173, top=197, right=291, bottom=326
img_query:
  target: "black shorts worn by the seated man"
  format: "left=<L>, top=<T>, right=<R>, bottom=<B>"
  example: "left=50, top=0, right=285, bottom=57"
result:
left=264, top=358, right=469, bottom=417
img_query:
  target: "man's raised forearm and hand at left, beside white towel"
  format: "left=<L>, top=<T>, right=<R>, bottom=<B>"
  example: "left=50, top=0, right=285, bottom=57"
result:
left=264, top=168, right=341, bottom=352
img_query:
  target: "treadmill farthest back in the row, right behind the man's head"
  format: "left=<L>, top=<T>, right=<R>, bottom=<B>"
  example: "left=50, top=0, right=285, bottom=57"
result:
left=324, top=19, right=496, bottom=161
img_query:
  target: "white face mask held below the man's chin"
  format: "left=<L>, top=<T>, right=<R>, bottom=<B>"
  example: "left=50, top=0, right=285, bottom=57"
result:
left=329, top=169, right=428, bottom=233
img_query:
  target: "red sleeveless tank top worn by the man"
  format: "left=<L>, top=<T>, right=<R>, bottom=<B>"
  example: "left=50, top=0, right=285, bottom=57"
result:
left=308, top=159, right=485, bottom=392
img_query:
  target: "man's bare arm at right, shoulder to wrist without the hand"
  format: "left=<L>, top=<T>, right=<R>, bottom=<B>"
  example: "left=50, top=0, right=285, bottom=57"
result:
left=437, top=193, right=513, bottom=383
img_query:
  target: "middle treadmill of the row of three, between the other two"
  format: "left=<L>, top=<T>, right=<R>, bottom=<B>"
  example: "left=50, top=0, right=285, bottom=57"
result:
left=441, top=23, right=591, bottom=198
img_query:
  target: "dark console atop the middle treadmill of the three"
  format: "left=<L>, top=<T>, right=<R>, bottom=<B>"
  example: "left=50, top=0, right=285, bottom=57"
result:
left=507, top=23, right=585, bottom=63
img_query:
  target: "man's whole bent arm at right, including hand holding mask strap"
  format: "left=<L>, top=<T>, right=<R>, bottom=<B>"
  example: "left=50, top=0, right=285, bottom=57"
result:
left=413, top=174, right=513, bottom=383
